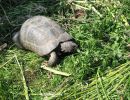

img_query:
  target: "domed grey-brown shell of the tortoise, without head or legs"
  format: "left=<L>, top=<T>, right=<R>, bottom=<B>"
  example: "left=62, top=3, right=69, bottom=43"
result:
left=20, top=16, right=72, bottom=56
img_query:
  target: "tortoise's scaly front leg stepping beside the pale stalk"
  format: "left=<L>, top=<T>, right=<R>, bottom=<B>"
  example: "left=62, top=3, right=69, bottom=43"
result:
left=48, top=51, right=58, bottom=66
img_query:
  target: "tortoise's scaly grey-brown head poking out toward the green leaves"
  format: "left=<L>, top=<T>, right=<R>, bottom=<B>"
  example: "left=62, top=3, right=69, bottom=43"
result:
left=61, top=41, right=78, bottom=53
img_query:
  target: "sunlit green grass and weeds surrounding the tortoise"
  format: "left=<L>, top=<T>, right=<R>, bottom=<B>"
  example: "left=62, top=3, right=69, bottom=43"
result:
left=0, top=0, right=130, bottom=100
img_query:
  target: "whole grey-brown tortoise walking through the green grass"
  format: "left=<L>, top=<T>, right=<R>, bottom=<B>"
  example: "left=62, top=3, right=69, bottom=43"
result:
left=13, top=15, right=78, bottom=66
